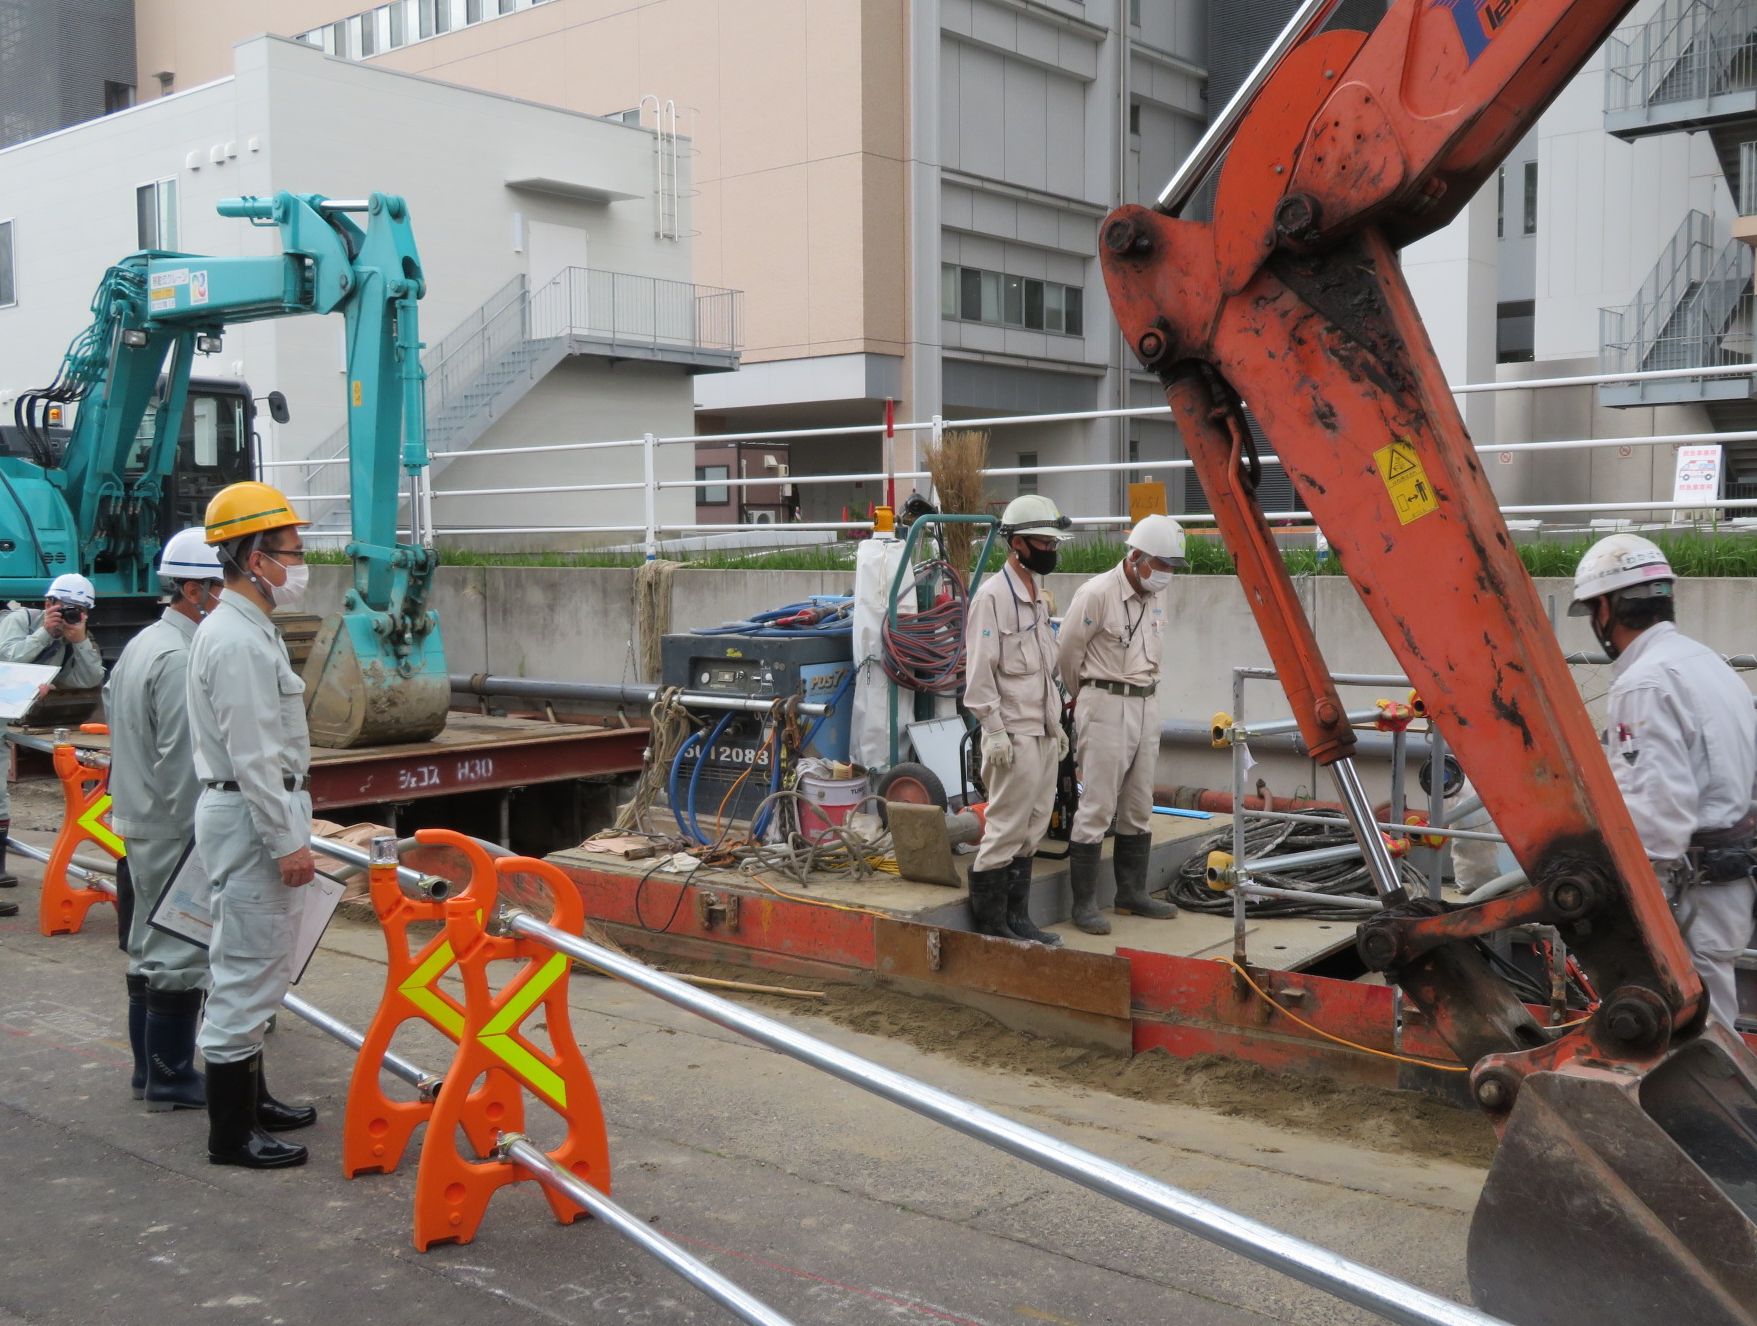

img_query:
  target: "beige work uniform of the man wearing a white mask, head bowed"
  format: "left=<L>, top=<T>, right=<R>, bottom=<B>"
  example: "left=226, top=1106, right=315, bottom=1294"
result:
left=1059, top=562, right=1165, bottom=843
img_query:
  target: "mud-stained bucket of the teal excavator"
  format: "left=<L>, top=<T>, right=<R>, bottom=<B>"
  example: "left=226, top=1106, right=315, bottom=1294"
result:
left=304, top=611, right=452, bottom=750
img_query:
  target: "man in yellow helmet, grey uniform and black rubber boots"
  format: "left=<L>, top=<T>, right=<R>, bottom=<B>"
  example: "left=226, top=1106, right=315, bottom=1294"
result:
left=188, top=483, right=316, bottom=1170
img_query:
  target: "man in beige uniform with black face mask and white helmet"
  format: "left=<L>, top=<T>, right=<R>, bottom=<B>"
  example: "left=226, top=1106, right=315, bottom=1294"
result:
left=965, top=494, right=1072, bottom=945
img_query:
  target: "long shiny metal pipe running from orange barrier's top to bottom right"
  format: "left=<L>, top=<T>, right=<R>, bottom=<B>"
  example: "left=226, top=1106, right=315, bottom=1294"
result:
left=501, top=910, right=1497, bottom=1326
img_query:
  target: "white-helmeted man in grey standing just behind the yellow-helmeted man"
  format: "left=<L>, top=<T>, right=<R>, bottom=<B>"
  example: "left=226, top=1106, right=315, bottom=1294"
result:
left=104, top=525, right=220, bottom=1112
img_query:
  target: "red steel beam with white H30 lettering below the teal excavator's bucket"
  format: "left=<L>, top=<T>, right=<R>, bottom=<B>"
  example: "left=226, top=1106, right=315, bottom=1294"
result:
left=311, top=727, right=647, bottom=810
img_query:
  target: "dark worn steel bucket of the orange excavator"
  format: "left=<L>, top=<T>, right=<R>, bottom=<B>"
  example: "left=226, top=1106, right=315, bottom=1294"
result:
left=1469, top=1026, right=1757, bottom=1326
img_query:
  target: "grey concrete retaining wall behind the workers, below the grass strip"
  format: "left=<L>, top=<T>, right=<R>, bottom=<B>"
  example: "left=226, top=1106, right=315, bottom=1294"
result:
left=311, top=566, right=1757, bottom=797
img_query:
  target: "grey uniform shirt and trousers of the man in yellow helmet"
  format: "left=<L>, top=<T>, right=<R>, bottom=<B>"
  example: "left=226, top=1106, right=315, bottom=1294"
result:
left=188, top=590, right=311, bottom=1064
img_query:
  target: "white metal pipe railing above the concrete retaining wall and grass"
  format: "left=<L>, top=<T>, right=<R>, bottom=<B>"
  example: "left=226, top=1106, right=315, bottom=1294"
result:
left=260, top=364, right=1757, bottom=557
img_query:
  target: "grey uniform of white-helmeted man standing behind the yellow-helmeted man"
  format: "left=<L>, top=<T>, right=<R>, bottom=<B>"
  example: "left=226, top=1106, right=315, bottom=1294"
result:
left=104, top=608, right=207, bottom=991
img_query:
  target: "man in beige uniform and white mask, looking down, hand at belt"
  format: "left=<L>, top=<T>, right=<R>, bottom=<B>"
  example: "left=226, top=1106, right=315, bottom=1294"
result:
left=1059, top=516, right=1188, bottom=934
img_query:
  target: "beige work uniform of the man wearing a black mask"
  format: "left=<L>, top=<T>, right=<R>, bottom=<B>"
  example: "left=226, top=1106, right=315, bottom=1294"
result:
left=965, top=562, right=1061, bottom=869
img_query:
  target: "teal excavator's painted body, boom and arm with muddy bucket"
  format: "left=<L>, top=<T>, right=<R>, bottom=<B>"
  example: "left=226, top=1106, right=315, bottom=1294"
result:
left=0, top=193, right=450, bottom=748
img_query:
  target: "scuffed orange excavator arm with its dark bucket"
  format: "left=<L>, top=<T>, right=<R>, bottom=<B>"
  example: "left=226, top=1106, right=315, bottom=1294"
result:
left=1102, top=0, right=1757, bottom=1326
